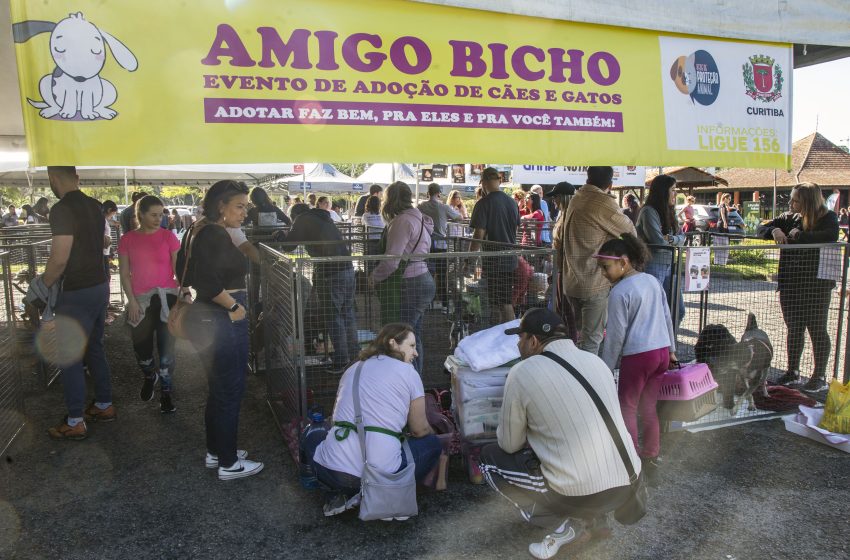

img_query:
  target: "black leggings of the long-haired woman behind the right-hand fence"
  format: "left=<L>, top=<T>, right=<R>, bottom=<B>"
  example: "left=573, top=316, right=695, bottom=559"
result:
left=779, top=287, right=832, bottom=379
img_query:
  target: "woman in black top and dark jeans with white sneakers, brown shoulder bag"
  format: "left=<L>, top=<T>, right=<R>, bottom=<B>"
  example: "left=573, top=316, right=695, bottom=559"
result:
left=177, top=181, right=263, bottom=480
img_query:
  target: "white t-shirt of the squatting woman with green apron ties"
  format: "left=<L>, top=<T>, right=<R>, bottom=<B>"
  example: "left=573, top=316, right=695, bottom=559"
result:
left=315, top=356, right=425, bottom=477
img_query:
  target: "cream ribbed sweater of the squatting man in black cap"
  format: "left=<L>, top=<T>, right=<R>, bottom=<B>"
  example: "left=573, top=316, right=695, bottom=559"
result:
left=497, top=339, right=640, bottom=496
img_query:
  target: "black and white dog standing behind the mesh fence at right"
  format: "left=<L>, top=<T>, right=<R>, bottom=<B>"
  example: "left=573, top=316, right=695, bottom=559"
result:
left=694, top=313, right=773, bottom=416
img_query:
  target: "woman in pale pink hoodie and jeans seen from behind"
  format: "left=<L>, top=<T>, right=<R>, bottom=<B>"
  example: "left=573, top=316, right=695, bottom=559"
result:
left=369, top=181, right=436, bottom=374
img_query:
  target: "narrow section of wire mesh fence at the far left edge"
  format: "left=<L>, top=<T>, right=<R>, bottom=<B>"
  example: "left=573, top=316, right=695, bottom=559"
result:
left=0, top=251, right=24, bottom=456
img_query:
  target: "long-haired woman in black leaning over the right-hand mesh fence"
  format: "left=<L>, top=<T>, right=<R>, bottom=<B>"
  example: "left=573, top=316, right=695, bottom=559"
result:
left=758, top=183, right=838, bottom=392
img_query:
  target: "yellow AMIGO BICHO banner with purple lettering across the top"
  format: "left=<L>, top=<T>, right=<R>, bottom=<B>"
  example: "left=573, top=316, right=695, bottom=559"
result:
left=11, top=0, right=792, bottom=168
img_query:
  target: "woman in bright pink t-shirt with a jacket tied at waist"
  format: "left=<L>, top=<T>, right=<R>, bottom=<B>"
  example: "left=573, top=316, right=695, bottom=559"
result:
left=118, top=196, right=180, bottom=413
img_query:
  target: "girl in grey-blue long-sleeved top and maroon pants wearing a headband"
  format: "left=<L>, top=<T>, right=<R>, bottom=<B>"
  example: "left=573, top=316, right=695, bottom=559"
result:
left=594, top=233, right=677, bottom=485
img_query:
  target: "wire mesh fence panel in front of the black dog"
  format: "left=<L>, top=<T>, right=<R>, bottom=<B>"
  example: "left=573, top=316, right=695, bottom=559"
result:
left=664, top=236, right=847, bottom=424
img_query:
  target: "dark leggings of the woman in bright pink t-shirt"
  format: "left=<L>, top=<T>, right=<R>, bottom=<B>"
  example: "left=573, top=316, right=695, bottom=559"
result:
left=132, top=294, right=177, bottom=392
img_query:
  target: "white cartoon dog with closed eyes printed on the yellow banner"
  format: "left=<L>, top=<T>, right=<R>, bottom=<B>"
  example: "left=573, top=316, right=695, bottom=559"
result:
left=12, top=12, right=139, bottom=120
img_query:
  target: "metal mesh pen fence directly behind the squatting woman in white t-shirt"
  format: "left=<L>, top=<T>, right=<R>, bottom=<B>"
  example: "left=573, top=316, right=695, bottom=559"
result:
left=260, top=241, right=551, bottom=447
